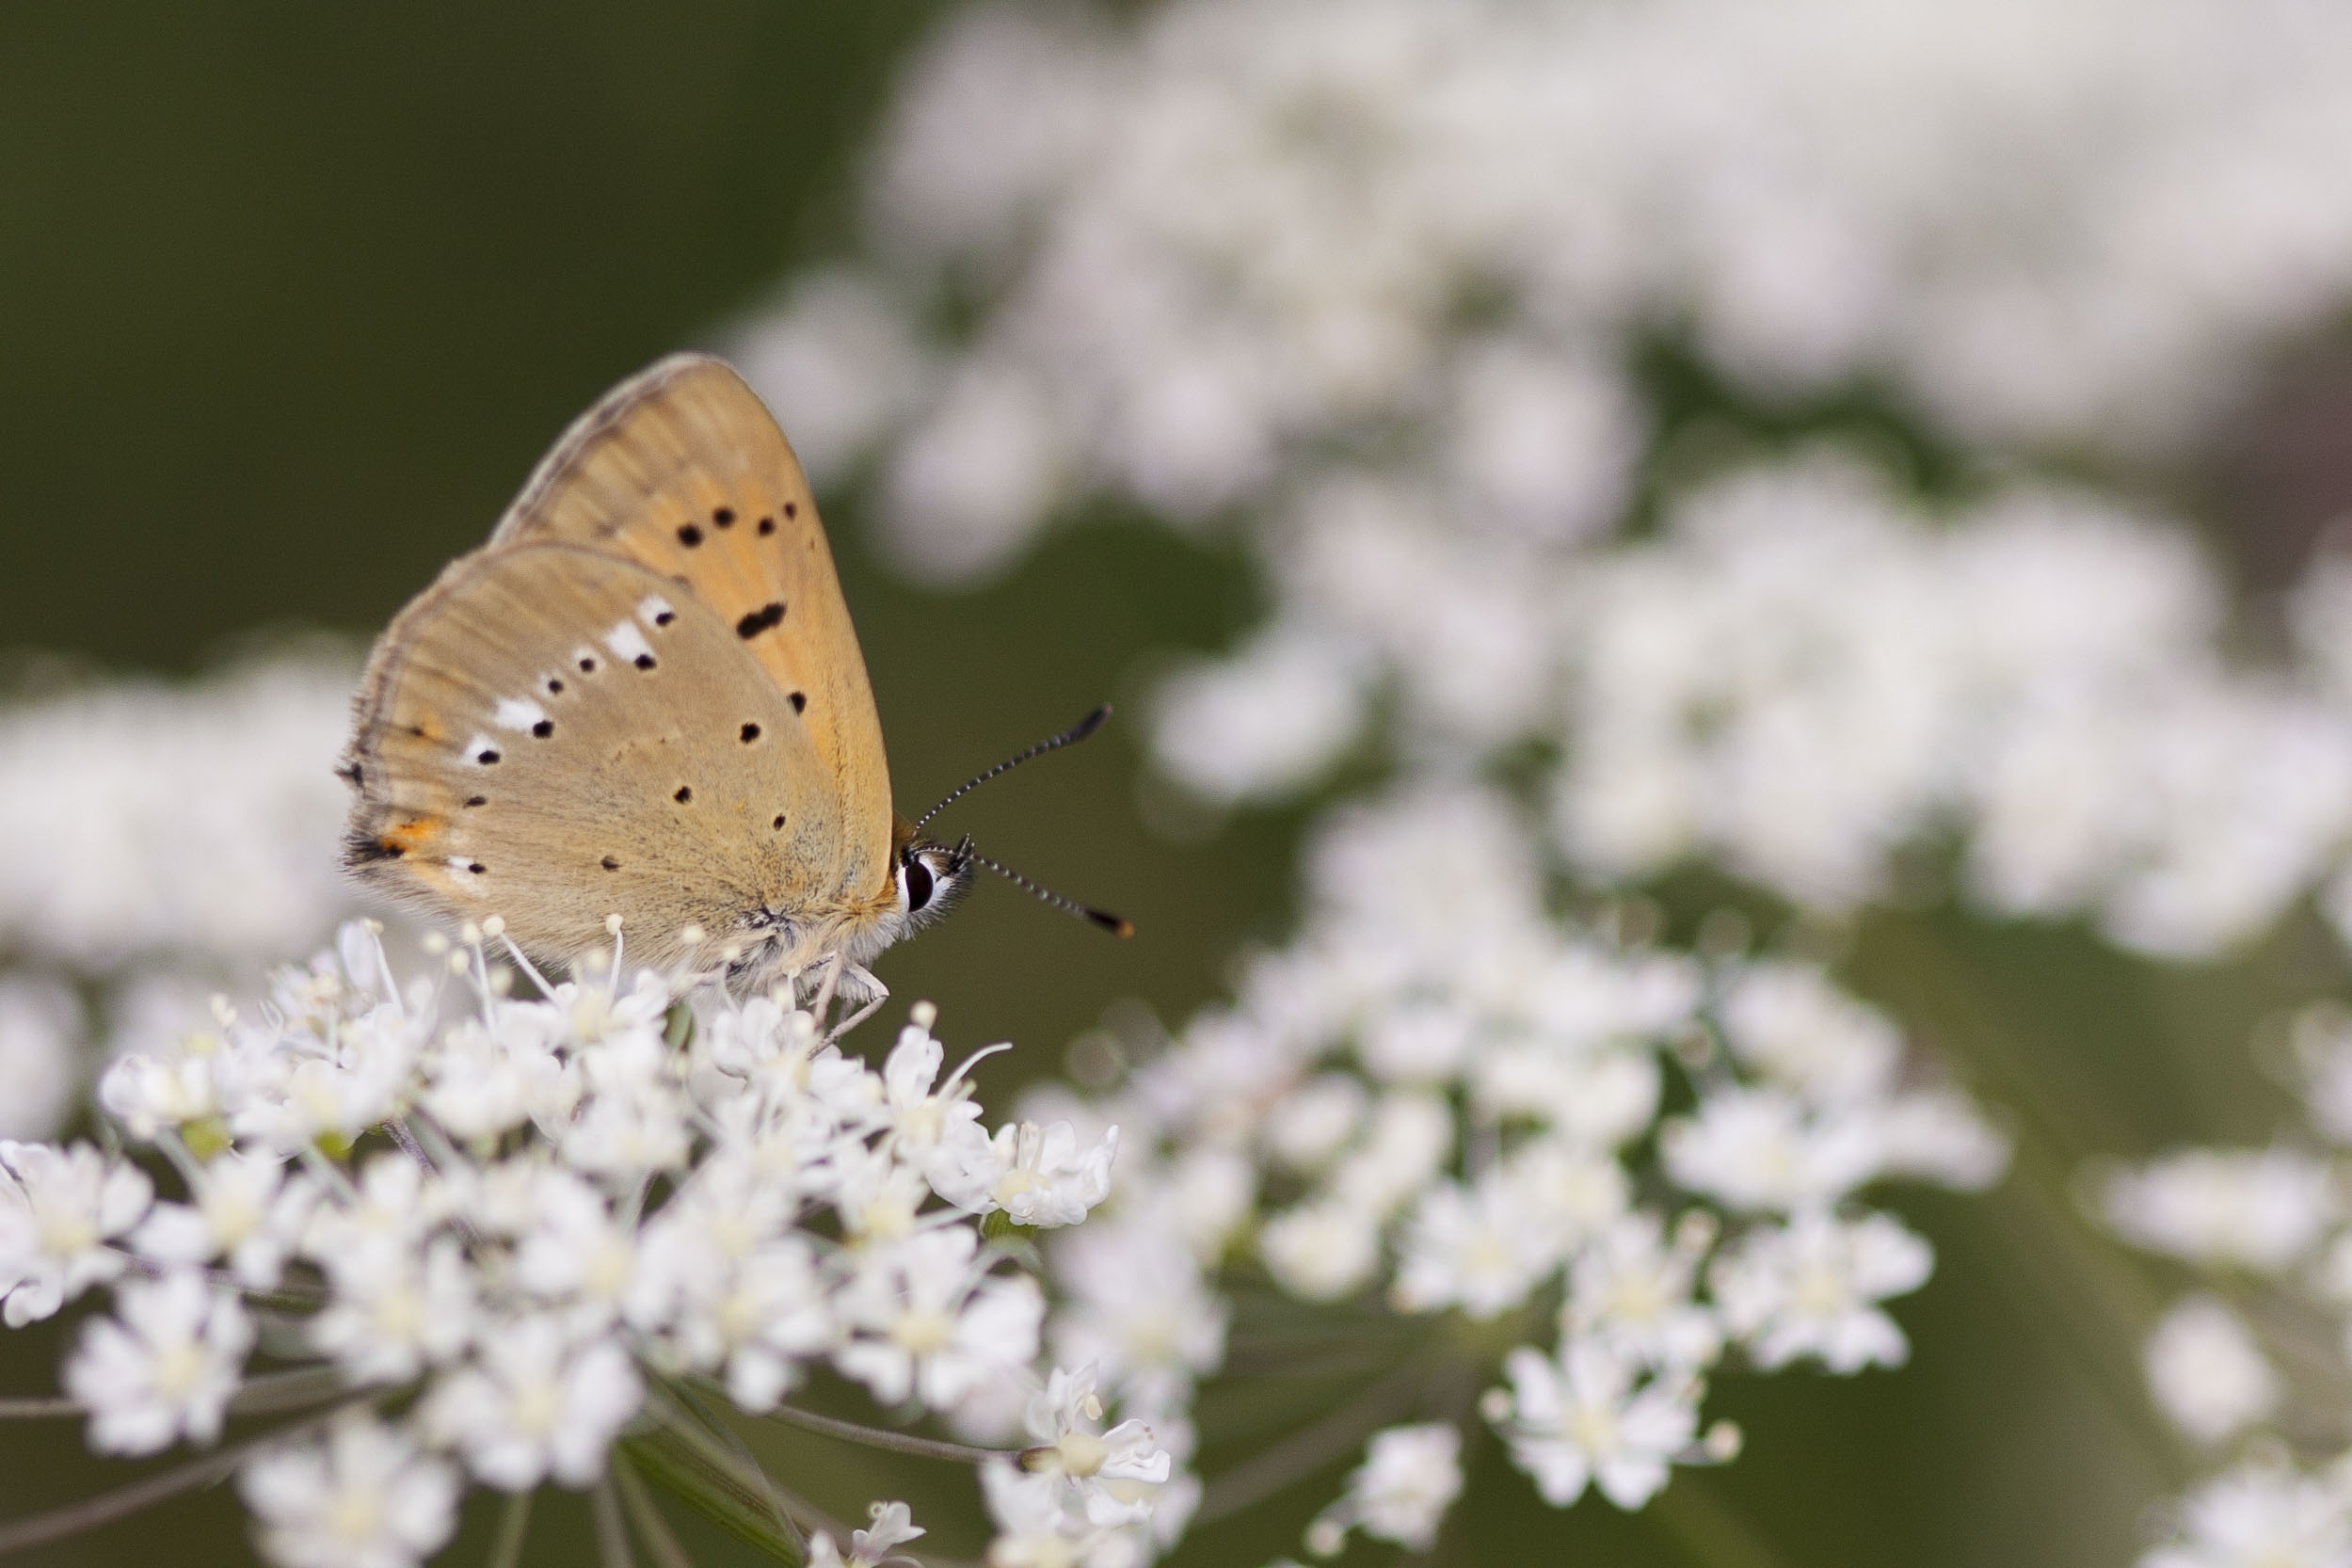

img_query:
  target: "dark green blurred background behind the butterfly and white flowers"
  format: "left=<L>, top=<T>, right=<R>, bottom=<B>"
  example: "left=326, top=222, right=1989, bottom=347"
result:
left=0, top=0, right=2341, bottom=1568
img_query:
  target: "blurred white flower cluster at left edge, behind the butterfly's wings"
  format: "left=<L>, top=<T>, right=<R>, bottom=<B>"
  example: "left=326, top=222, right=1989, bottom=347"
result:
left=0, top=653, right=355, bottom=1138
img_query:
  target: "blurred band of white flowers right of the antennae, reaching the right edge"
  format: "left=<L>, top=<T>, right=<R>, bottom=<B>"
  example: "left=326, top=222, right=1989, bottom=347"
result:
left=1155, top=449, right=2352, bottom=957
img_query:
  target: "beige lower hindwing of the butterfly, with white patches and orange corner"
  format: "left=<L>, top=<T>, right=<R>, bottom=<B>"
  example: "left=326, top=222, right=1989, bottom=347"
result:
left=345, top=543, right=837, bottom=967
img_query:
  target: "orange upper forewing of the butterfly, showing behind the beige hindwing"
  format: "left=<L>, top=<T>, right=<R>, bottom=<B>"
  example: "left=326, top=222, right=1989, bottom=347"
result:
left=491, top=355, right=891, bottom=896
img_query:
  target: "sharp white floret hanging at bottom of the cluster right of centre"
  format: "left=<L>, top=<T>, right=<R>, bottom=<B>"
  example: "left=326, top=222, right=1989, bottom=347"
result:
left=1500, top=1340, right=1698, bottom=1510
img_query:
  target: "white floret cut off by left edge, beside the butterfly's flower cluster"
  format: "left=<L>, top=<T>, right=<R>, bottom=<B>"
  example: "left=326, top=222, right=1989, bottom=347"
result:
left=0, top=1143, right=155, bottom=1328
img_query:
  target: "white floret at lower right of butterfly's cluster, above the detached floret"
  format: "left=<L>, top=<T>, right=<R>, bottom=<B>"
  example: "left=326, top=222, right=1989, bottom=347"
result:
left=833, top=1227, right=1045, bottom=1411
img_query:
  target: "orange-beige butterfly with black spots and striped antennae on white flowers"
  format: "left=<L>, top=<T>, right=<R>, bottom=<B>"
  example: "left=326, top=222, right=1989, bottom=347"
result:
left=341, top=355, right=1129, bottom=1006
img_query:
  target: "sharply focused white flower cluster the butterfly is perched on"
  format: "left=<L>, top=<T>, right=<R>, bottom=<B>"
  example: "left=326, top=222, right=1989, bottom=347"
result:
left=0, top=921, right=1169, bottom=1568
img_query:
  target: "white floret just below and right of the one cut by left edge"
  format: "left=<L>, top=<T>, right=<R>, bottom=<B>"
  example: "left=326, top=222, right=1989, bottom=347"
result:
left=63, top=1272, right=254, bottom=1453
